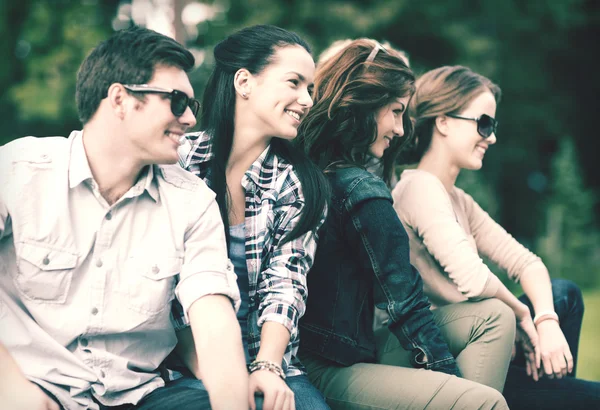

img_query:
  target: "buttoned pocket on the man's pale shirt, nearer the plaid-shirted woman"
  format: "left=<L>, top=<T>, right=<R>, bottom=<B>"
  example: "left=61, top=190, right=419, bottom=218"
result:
left=124, top=254, right=183, bottom=316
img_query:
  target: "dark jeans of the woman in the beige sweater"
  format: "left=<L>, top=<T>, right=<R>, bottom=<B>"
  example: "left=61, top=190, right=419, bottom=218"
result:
left=504, top=279, right=600, bottom=410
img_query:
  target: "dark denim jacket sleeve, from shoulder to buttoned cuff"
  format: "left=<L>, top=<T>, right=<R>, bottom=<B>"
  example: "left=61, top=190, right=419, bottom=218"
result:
left=344, top=177, right=460, bottom=376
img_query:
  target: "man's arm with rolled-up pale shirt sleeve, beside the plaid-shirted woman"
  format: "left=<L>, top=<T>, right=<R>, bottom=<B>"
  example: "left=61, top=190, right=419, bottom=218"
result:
left=175, top=195, right=248, bottom=409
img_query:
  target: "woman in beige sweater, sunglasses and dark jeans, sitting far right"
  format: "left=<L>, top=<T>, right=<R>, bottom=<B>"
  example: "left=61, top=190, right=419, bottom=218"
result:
left=392, top=66, right=600, bottom=409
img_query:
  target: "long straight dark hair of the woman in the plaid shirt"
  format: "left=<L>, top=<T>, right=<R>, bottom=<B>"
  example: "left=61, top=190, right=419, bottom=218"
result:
left=201, top=25, right=328, bottom=243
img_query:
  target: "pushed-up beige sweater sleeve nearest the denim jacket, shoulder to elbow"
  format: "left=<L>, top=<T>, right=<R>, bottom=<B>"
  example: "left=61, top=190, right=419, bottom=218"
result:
left=393, top=172, right=500, bottom=299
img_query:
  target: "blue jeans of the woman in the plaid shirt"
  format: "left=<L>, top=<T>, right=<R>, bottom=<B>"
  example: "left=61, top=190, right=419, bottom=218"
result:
left=176, top=375, right=330, bottom=410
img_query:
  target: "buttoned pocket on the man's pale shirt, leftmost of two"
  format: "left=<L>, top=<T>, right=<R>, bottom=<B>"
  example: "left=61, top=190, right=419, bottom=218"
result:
left=14, top=242, right=78, bottom=304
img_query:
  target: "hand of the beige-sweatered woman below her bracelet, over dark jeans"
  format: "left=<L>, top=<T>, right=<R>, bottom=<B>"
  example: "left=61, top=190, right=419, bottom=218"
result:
left=537, top=320, right=573, bottom=379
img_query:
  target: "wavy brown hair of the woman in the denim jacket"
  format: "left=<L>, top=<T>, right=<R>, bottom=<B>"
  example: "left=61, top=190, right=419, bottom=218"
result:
left=296, top=39, right=415, bottom=183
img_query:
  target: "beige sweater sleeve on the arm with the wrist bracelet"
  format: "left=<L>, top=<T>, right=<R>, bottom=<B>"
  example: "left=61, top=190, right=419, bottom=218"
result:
left=456, top=188, right=543, bottom=282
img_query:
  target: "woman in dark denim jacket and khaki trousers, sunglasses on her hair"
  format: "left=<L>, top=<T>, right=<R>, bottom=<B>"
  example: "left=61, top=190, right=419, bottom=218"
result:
left=297, top=39, right=515, bottom=409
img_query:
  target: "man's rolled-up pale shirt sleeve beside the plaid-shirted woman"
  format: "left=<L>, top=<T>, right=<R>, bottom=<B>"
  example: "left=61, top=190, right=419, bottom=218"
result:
left=174, top=195, right=240, bottom=327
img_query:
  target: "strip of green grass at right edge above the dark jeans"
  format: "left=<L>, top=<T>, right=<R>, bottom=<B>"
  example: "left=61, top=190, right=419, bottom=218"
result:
left=577, top=289, right=600, bottom=381
